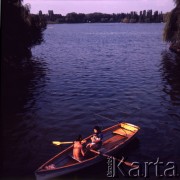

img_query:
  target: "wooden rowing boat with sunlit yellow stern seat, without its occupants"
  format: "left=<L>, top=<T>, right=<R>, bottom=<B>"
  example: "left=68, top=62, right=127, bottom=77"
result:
left=35, top=122, right=140, bottom=180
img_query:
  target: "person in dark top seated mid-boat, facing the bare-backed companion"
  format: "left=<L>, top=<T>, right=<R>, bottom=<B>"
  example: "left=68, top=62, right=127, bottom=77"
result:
left=86, top=126, right=103, bottom=150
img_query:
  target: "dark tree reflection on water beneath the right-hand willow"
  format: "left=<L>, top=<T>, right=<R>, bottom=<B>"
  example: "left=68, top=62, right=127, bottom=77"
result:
left=161, top=51, right=180, bottom=106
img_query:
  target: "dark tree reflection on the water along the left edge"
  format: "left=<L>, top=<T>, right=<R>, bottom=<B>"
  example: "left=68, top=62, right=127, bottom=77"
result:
left=1, top=57, right=46, bottom=177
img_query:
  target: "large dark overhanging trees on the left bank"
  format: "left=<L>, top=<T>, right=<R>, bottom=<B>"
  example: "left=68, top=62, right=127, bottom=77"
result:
left=1, top=0, right=46, bottom=67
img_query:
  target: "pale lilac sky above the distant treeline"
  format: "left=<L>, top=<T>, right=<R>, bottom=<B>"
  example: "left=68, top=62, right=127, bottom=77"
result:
left=23, top=0, right=175, bottom=15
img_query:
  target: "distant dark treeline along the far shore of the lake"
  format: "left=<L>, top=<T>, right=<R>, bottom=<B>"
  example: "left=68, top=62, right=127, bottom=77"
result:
left=39, top=10, right=166, bottom=23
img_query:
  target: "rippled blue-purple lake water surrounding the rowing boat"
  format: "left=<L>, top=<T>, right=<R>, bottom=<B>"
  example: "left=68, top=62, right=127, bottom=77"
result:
left=3, top=23, right=180, bottom=179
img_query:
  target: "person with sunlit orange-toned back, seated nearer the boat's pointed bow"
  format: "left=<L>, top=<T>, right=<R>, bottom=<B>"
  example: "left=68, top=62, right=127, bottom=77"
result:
left=73, top=135, right=85, bottom=161
